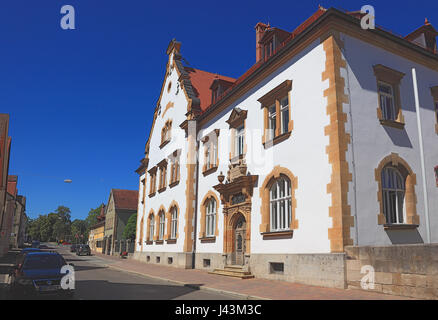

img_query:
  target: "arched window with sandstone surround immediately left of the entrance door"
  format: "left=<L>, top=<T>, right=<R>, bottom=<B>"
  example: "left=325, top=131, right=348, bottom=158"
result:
left=199, top=191, right=219, bottom=242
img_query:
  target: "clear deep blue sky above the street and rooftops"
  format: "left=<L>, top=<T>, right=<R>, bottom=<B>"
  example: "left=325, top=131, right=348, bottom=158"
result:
left=0, top=0, right=438, bottom=219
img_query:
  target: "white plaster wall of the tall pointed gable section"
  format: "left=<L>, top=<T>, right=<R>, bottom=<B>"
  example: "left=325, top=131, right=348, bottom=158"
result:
left=137, top=55, right=187, bottom=252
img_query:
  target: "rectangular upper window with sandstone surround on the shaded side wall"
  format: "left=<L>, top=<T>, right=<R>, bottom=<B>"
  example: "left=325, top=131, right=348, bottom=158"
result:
left=373, top=64, right=405, bottom=129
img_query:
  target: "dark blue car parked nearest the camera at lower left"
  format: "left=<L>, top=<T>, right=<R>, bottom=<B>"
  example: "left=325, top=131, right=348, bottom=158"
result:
left=10, top=251, right=74, bottom=298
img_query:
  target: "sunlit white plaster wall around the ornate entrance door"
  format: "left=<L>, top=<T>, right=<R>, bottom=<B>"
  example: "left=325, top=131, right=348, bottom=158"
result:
left=197, top=41, right=331, bottom=253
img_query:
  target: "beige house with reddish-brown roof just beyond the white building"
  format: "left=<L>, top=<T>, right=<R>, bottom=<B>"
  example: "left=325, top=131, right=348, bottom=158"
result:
left=102, top=189, right=138, bottom=255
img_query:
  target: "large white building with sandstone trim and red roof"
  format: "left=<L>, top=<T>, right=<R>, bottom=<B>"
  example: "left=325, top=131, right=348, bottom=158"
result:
left=133, top=7, right=438, bottom=298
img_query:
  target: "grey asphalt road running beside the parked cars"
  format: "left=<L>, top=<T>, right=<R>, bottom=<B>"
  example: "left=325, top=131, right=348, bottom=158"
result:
left=9, top=246, right=238, bottom=300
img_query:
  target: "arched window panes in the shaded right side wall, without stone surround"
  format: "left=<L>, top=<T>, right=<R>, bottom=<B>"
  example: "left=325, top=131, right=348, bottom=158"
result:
left=381, top=166, right=406, bottom=224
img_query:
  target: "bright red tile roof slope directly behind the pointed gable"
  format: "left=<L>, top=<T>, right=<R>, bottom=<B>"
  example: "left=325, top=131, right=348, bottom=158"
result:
left=184, top=67, right=236, bottom=111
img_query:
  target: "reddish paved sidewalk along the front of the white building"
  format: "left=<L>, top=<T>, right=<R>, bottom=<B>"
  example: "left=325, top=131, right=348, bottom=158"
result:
left=93, top=252, right=410, bottom=300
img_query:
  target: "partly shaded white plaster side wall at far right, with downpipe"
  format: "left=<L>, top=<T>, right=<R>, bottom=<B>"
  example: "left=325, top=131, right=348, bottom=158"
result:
left=341, top=35, right=438, bottom=245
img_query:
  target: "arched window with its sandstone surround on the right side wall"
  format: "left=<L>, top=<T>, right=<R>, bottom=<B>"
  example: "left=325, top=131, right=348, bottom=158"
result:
left=374, top=153, right=420, bottom=229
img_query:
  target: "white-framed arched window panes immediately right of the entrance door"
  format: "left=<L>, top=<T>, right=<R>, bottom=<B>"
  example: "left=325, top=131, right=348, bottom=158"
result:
left=270, top=176, right=292, bottom=231
